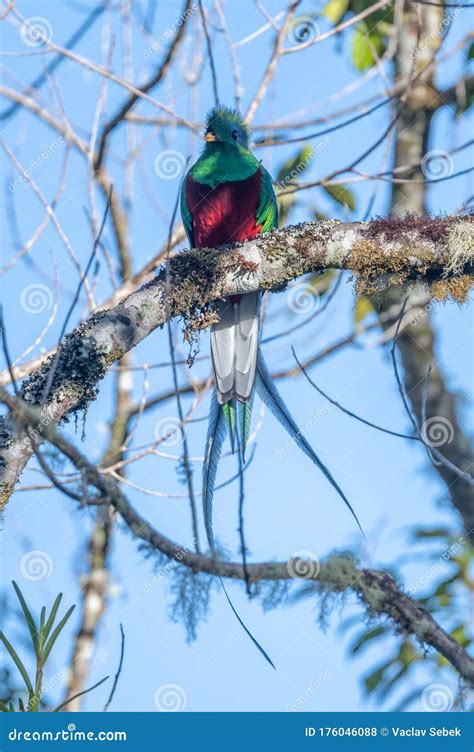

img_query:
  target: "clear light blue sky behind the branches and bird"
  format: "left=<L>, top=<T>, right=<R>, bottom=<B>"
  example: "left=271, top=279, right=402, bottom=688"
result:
left=0, top=0, right=473, bottom=711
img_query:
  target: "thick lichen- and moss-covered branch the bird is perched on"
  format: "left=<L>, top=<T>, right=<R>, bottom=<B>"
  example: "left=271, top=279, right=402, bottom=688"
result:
left=0, top=216, right=474, bottom=503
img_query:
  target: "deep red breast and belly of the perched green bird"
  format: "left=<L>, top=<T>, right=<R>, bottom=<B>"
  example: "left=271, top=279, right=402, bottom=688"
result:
left=185, top=168, right=262, bottom=248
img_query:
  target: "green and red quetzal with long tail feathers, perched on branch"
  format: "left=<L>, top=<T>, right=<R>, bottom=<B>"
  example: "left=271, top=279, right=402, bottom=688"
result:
left=181, top=106, right=357, bottom=548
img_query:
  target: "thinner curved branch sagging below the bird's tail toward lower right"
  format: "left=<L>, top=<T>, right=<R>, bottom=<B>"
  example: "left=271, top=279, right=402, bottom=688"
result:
left=0, top=390, right=474, bottom=686
